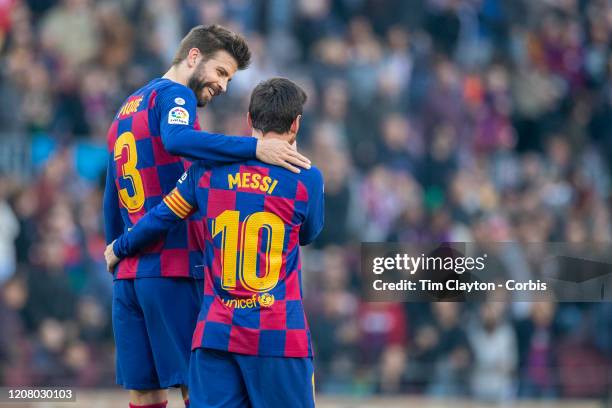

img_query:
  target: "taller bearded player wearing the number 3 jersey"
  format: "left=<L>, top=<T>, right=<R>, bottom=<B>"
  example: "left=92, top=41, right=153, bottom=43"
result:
left=104, top=25, right=309, bottom=408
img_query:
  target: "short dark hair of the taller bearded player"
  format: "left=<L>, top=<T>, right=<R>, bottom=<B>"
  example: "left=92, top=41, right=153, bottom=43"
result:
left=172, top=24, right=251, bottom=69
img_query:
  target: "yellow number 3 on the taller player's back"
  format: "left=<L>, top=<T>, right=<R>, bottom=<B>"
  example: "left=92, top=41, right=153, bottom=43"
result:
left=114, top=132, right=145, bottom=213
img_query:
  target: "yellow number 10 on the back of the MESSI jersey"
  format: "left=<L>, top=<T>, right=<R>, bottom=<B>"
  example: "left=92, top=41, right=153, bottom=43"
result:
left=212, top=210, right=285, bottom=292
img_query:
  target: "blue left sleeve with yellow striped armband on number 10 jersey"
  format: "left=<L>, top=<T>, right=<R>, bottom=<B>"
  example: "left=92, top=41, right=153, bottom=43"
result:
left=113, top=161, right=200, bottom=258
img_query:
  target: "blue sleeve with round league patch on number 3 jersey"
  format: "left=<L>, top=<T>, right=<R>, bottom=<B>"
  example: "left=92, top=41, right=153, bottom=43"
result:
left=157, top=84, right=257, bottom=164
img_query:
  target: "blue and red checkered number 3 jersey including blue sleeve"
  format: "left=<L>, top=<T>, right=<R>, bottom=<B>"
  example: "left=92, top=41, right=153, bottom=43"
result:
left=104, top=78, right=257, bottom=279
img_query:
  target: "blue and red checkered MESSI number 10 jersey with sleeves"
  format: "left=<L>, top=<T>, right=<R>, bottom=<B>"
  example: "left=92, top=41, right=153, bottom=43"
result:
left=114, top=160, right=323, bottom=357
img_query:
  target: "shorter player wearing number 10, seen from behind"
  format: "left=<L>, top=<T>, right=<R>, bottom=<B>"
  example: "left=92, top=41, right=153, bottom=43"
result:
left=105, top=78, right=323, bottom=408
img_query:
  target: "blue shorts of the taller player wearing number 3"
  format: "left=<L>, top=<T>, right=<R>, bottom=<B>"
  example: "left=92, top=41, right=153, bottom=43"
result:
left=113, top=278, right=204, bottom=390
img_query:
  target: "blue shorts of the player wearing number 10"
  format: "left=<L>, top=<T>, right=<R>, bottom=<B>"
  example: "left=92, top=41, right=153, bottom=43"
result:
left=189, top=348, right=314, bottom=408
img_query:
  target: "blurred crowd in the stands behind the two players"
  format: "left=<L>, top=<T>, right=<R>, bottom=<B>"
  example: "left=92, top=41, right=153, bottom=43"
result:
left=0, top=0, right=612, bottom=401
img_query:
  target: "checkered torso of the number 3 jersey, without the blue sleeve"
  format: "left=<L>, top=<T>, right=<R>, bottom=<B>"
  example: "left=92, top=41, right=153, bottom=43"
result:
left=107, top=79, right=203, bottom=279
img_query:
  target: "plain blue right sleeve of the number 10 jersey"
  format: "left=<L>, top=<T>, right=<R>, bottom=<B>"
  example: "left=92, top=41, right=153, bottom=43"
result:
left=300, top=167, right=325, bottom=245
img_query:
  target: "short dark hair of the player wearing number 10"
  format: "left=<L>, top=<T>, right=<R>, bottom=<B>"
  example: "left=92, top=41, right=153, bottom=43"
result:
left=249, top=78, right=307, bottom=133
